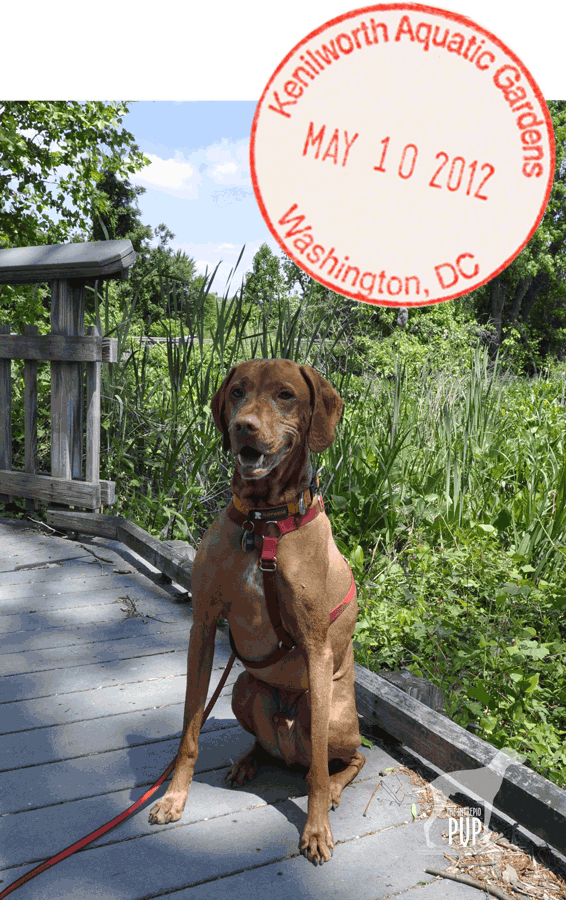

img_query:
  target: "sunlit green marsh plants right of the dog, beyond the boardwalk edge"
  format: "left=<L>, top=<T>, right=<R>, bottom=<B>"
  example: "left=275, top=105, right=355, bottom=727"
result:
left=328, top=351, right=566, bottom=784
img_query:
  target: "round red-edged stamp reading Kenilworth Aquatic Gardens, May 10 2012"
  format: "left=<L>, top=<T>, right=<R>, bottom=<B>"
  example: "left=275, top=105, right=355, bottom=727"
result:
left=250, top=3, right=554, bottom=306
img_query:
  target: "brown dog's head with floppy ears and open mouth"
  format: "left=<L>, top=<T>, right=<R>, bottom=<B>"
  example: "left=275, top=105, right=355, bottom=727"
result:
left=211, top=359, right=343, bottom=480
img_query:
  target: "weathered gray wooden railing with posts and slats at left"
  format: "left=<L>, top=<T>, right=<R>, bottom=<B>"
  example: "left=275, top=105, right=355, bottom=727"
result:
left=0, top=240, right=136, bottom=510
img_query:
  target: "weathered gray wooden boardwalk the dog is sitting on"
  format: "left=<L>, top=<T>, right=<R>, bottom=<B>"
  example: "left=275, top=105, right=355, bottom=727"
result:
left=0, top=519, right=544, bottom=900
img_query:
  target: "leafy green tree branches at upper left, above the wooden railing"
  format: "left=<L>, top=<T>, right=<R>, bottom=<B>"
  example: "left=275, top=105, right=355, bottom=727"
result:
left=0, top=100, right=149, bottom=247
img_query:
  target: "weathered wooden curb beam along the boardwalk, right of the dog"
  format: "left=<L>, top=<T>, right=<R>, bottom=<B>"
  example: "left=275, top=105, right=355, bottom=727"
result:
left=355, top=664, right=566, bottom=853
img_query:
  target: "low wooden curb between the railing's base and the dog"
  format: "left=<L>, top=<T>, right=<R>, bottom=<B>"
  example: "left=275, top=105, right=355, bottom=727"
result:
left=47, top=504, right=192, bottom=591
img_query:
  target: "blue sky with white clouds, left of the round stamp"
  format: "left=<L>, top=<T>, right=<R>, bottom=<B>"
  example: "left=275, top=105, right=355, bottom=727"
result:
left=124, top=101, right=270, bottom=291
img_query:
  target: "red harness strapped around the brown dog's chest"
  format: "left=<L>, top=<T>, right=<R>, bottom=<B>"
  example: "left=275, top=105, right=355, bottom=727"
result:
left=227, top=494, right=356, bottom=669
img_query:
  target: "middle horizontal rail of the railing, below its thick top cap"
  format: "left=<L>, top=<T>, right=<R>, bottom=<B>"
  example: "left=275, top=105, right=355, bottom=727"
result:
left=0, top=325, right=104, bottom=362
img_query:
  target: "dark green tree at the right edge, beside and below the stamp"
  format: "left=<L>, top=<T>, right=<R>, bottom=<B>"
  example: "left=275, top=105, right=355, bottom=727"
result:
left=474, top=100, right=566, bottom=365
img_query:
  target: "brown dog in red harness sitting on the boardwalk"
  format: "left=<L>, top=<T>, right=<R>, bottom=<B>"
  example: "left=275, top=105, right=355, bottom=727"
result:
left=149, top=359, right=365, bottom=864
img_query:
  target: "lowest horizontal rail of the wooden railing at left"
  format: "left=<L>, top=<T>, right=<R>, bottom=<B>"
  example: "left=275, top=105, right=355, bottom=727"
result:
left=0, top=469, right=116, bottom=509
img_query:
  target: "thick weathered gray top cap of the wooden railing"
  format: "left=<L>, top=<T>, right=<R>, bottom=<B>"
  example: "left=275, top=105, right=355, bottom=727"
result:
left=0, top=240, right=136, bottom=284
